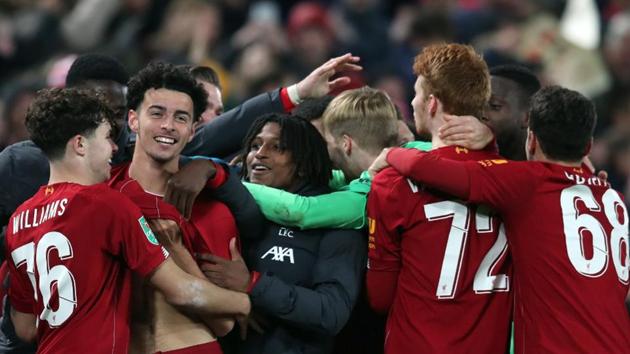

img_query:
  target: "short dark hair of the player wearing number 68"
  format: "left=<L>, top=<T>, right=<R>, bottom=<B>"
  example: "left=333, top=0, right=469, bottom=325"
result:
left=529, top=86, right=597, bottom=162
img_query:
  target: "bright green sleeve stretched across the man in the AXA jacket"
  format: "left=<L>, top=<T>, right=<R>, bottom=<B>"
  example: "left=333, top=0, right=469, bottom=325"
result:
left=244, top=182, right=366, bottom=229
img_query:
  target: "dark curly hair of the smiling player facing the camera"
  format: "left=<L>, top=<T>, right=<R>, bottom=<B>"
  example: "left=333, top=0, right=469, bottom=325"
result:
left=127, top=62, right=208, bottom=122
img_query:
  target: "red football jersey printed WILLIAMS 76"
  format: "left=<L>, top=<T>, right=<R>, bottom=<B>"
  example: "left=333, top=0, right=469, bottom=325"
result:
left=6, top=183, right=168, bottom=353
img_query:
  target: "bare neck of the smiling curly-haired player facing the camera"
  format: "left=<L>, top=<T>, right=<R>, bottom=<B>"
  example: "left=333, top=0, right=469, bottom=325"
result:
left=129, top=153, right=179, bottom=195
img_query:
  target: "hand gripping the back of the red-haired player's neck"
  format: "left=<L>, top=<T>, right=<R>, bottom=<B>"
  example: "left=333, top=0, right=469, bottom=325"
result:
left=438, top=113, right=494, bottom=150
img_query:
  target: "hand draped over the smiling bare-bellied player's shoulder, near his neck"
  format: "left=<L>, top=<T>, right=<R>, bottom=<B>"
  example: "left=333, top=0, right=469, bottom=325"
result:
left=164, top=159, right=217, bottom=219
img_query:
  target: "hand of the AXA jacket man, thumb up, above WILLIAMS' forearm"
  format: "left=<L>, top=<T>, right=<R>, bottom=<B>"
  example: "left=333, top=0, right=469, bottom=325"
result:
left=197, top=237, right=250, bottom=292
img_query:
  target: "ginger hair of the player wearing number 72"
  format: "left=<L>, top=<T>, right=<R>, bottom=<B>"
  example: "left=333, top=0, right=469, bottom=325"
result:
left=413, top=43, right=490, bottom=118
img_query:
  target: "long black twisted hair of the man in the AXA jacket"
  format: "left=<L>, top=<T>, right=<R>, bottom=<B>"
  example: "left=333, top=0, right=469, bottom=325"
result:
left=241, top=113, right=332, bottom=187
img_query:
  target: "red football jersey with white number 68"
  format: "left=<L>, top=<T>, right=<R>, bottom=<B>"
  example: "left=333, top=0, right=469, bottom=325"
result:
left=467, top=162, right=630, bottom=353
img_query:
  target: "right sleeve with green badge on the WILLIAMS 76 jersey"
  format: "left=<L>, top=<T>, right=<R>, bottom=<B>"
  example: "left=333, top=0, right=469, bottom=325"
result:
left=102, top=191, right=168, bottom=277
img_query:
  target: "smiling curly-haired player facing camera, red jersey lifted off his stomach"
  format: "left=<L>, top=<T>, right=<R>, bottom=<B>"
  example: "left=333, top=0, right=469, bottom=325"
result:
left=108, top=63, right=238, bottom=353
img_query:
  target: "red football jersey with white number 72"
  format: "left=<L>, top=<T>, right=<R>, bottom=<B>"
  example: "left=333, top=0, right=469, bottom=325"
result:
left=368, top=147, right=512, bottom=354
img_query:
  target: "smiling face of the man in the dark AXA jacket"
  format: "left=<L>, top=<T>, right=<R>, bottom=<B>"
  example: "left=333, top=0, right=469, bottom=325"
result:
left=246, top=123, right=297, bottom=190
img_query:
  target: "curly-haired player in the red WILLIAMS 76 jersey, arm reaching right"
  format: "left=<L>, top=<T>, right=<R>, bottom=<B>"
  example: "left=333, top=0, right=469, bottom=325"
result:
left=6, top=89, right=250, bottom=353
